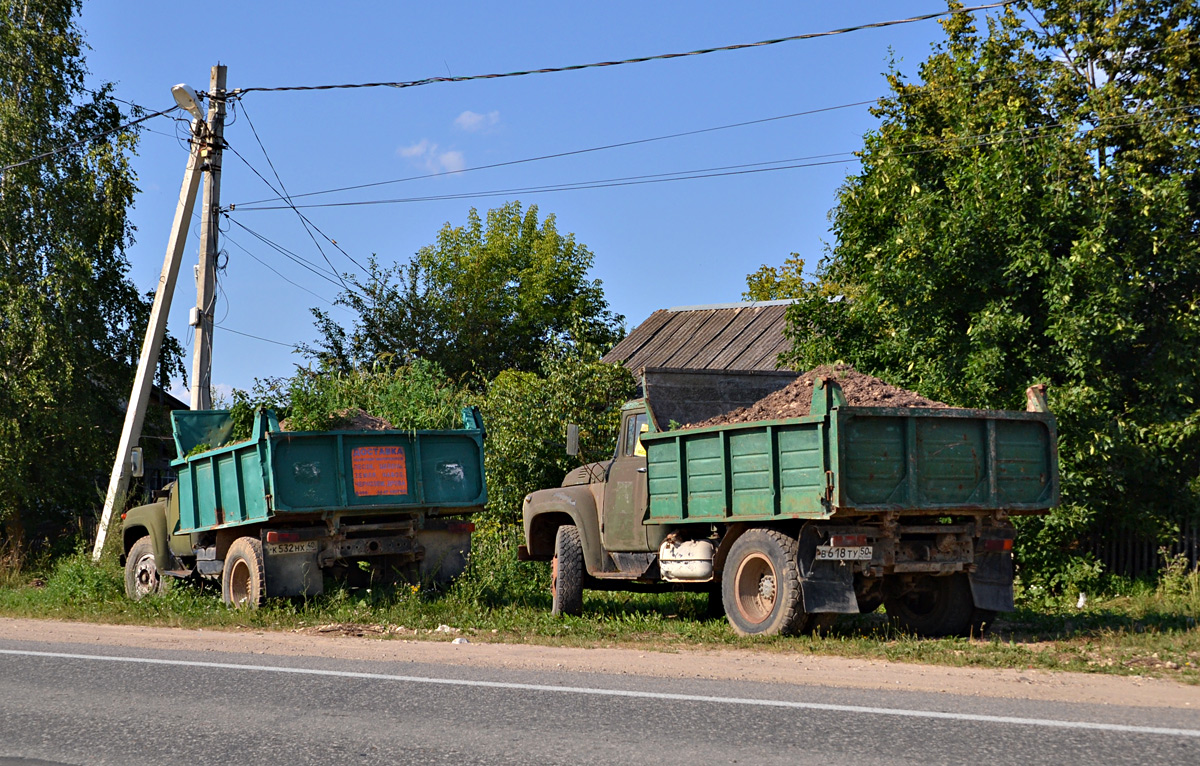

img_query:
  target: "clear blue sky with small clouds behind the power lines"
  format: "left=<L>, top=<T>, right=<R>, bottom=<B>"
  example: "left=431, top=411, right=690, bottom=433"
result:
left=80, top=0, right=1008, bottom=394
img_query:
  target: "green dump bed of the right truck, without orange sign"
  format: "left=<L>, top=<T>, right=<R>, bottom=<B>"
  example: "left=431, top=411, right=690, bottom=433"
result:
left=642, top=406, right=1058, bottom=523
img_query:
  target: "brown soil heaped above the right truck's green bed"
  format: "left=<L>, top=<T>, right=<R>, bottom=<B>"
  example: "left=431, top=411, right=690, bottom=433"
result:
left=684, top=364, right=948, bottom=429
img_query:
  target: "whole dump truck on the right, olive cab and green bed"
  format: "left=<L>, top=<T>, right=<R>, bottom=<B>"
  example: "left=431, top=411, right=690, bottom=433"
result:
left=521, top=373, right=1058, bottom=636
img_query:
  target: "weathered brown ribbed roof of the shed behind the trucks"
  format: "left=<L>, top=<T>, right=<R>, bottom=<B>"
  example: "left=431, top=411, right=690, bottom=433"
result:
left=604, top=300, right=792, bottom=370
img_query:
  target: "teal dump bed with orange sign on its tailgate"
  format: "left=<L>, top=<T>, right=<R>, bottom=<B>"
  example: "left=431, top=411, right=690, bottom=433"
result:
left=172, top=408, right=487, bottom=532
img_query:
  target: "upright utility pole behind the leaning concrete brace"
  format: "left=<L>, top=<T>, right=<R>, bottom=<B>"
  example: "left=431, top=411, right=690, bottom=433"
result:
left=192, top=64, right=226, bottom=409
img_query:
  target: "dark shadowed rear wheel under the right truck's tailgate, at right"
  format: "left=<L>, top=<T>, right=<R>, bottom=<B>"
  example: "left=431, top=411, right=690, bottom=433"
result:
left=883, top=573, right=974, bottom=639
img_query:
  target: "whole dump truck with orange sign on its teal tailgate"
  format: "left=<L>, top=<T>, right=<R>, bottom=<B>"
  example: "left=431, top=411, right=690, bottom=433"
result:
left=122, top=408, right=487, bottom=608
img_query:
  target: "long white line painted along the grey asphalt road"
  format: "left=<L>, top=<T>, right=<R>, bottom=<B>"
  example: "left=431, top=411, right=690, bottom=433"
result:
left=7, top=650, right=1200, bottom=738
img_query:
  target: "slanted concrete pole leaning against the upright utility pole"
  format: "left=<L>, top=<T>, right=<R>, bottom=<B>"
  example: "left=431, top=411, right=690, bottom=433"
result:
left=91, top=120, right=205, bottom=561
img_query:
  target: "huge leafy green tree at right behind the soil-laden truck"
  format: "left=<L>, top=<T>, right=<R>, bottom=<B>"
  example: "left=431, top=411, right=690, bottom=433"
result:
left=787, top=0, right=1200, bottom=588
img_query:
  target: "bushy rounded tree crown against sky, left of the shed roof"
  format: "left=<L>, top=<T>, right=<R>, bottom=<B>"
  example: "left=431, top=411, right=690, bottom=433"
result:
left=308, top=202, right=624, bottom=381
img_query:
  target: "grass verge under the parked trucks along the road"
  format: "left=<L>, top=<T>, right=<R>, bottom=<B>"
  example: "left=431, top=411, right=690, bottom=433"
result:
left=0, top=542, right=1200, bottom=683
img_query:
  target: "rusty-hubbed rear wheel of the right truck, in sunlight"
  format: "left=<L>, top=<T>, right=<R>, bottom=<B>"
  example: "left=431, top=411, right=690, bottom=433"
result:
left=721, top=529, right=808, bottom=635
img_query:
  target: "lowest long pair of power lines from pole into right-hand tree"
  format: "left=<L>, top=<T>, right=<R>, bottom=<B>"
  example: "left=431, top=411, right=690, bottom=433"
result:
left=229, top=104, right=1200, bottom=210
